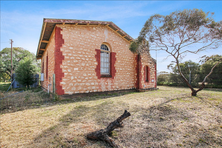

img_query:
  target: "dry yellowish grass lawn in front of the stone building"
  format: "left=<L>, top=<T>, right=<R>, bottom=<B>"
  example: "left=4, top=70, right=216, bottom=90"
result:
left=0, top=86, right=222, bottom=148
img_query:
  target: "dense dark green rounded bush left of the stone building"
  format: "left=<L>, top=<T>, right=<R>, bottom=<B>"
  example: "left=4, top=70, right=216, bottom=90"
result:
left=15, top=58, right=36, bottom=89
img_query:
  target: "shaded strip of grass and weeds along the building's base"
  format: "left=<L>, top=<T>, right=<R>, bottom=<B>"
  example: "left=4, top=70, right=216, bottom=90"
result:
left=0, top=88, right=140, bottom=113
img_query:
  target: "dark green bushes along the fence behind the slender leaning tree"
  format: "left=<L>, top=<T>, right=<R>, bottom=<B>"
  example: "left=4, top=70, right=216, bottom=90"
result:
left=158, top=55, right=222, bottom=88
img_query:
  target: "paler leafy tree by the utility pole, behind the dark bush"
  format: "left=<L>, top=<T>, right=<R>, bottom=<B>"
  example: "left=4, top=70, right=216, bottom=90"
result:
left=0, top=47, right=40, bottom=79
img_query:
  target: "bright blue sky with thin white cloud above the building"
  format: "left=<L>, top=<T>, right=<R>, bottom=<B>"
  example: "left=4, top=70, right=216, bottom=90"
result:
left=0, top=0, right=222, bottom=72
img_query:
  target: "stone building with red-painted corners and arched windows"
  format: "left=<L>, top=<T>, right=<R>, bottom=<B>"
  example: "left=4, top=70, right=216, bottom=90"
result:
left=36, top=19, right=156, bottom=95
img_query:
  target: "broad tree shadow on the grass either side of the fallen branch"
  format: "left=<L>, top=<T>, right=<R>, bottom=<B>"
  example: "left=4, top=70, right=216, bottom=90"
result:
left=30, top=94, right=222, bottom=148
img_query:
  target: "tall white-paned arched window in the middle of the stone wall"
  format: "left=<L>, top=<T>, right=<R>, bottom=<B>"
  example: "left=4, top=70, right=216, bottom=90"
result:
left=100, top=44, right=110, bottom=75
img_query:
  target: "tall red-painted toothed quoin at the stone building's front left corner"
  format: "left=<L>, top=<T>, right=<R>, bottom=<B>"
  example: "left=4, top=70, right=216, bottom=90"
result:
left=55, top=26, right=64, bottom=95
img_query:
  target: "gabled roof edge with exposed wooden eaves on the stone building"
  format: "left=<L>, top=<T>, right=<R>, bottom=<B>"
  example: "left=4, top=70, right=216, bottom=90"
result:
left=36, top=18, right=133, bottom=59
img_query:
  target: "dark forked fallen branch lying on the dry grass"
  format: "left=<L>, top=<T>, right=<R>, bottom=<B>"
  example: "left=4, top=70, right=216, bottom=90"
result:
left=87, top=110, right=130, bottom=148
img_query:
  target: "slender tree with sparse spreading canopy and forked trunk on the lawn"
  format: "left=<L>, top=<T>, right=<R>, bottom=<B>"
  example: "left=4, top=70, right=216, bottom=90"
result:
left=130, top=9, right=222, bottom=96
